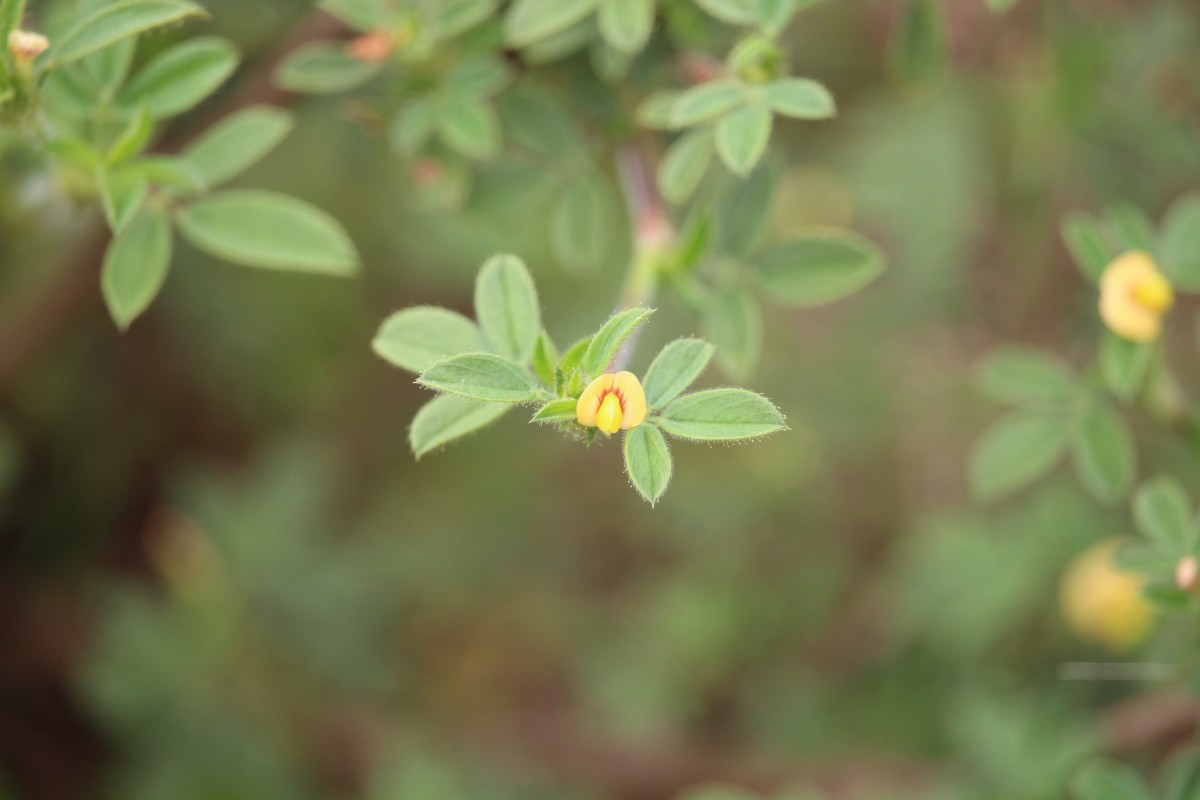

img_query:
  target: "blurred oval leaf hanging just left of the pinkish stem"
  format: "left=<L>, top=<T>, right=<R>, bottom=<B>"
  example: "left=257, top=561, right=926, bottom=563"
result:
left=550, top=170, right=618, bottom=272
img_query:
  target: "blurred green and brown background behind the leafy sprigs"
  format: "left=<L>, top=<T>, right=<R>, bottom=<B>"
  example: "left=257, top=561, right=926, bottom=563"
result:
left=0, top=0, right=1200, bottom=800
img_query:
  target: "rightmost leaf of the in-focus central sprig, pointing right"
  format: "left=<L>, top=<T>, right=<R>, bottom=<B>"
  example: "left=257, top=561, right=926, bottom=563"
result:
left=659, top=389, right=787, bottom=441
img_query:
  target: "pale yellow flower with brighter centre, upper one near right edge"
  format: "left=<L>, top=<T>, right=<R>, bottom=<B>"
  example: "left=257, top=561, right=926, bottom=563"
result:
left=1100, top=251, right=1175, bottom=342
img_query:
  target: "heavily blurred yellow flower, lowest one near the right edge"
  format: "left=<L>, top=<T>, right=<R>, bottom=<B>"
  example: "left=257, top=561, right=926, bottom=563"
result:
left=1058, top=540, right=1153, bottom=651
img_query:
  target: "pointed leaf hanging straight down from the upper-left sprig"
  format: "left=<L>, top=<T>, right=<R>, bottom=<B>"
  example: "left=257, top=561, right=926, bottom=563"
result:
left=100, top=210, right=170, bottom=331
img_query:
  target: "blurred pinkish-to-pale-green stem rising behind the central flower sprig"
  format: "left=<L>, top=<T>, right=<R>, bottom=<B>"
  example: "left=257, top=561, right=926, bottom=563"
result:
left=608, top=140, right=674, bottom=372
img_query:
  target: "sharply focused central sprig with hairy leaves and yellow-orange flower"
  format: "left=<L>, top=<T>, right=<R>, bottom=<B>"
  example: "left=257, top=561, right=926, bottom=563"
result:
left=372, top=255, right=786, bottom=505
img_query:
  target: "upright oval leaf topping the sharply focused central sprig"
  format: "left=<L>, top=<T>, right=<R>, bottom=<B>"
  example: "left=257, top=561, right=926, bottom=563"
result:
left=475, top=255, right=541, bottom=363
